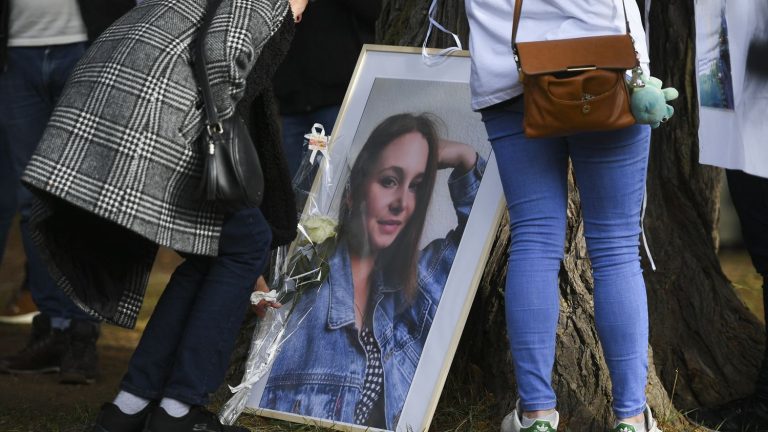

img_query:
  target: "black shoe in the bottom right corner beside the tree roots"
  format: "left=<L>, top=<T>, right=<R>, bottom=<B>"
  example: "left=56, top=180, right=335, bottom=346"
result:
left=688, top=396, right=768, bottom=432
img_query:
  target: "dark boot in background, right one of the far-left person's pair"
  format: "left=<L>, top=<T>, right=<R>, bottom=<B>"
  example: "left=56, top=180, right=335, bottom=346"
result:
left=59, top=320, right=99, bottom=384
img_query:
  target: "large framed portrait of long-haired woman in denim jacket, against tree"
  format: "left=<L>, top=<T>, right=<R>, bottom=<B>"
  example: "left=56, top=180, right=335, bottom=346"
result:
left=246, top=45, right=504, bottom=432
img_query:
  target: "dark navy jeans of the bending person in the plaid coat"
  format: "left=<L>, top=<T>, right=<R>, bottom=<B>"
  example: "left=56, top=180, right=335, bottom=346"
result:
left=121, top=209, right=272, bottom=405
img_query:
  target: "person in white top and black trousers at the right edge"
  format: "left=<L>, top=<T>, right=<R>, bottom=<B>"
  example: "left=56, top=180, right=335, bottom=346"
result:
left=690, top=2, right=768, bottom=432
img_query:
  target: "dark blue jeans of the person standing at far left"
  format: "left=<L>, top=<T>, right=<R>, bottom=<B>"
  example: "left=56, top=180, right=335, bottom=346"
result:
left=0, top=42, right=94, bottom=326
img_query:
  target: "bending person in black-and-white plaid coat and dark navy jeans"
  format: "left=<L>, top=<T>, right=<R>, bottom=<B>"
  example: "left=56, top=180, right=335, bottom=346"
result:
left=22, top=0, right=307, bottom=432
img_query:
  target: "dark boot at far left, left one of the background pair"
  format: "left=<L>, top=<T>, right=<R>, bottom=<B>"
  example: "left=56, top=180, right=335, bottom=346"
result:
left=0, top=314, right=67, bottom=374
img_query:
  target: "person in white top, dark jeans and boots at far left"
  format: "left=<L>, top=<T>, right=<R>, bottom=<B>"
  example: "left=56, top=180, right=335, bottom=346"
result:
left=0, top=0, right=135, bottom=384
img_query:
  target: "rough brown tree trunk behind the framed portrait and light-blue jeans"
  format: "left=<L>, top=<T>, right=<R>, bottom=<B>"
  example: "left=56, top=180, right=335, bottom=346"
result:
left=377, top=0, right=763, bottom=430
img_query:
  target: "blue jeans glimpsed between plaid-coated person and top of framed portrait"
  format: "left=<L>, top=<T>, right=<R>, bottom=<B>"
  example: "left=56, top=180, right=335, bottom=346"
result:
left=280, top=105, right=341, bottom=178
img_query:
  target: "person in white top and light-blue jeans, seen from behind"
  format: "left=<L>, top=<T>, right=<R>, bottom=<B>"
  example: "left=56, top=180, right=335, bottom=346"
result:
left=465, top=0, right=659, bottom=432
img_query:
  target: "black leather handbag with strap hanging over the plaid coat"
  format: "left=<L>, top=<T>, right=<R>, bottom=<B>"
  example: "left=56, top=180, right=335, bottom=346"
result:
left=194, top=0, right=264, bottom=211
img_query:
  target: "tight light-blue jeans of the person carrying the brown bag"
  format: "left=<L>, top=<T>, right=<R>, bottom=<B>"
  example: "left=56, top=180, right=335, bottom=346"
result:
left=482, top=98, right=650, bottom=418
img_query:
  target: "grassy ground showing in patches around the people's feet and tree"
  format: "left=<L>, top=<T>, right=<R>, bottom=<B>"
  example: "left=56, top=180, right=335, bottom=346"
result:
left=0, top=221, right=764, bottom=432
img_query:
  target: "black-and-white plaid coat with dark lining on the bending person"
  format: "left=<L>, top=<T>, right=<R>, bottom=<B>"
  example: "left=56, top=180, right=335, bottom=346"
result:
left=23, top=0, right=290, bottom=327
